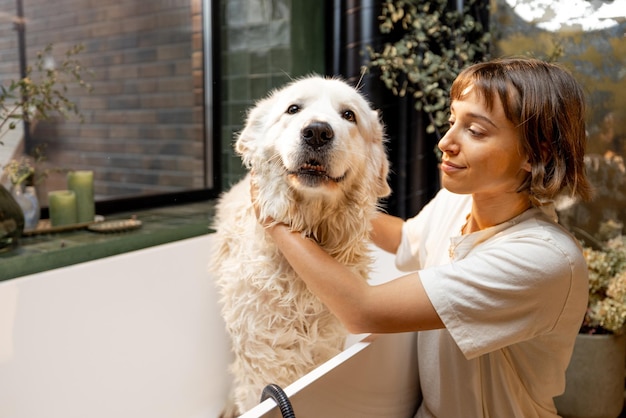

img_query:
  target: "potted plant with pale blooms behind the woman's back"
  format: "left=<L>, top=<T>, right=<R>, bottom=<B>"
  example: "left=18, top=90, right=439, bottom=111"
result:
left=555, top=221, right=626, bottom=418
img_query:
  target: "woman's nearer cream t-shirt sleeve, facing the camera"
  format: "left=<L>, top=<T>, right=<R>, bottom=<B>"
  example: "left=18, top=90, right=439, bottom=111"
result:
left=420, top=227, right=587, bottom=358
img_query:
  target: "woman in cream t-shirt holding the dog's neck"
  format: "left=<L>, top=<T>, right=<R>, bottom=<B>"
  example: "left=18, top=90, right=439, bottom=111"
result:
left=253, top=59, right=591, bottom=418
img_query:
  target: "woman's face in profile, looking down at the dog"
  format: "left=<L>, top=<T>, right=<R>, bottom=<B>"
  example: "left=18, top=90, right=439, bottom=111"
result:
left=439, top=87, right=530, bottom=197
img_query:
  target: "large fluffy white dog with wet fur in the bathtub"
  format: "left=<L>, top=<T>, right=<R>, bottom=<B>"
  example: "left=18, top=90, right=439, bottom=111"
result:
left=210, top=76, right=390, bottom=412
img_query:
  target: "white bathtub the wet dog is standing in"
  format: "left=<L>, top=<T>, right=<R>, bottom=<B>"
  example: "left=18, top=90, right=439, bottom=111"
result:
left=0, top=235, right=418, bottom=418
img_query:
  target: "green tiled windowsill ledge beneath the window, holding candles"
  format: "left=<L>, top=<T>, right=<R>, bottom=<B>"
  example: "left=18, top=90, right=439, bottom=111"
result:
left=0, top=201, right=214, bottom=281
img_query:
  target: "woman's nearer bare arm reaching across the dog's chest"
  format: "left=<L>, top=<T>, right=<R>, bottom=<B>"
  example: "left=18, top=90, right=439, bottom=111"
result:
left=265, top=222, right=443, bottom=334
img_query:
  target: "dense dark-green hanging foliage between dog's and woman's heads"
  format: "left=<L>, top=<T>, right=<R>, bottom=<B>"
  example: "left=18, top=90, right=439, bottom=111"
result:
left=367, top=0, right=491, bottom=136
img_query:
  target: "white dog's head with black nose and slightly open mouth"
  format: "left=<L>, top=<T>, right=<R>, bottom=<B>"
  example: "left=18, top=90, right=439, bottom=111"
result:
left=235, top=76, right=390, bottom=204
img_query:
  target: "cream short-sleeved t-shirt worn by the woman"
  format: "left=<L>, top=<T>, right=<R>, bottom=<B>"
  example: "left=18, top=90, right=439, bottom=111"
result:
left=396, top=190, right=588, bottom=418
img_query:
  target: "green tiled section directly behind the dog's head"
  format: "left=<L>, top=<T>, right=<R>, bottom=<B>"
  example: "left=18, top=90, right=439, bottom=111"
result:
left=219, top=0, right=325, bottom=190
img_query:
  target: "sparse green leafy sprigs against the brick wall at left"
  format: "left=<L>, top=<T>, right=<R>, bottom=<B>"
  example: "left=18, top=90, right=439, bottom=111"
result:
left=0, top=45, right=92, bottom=145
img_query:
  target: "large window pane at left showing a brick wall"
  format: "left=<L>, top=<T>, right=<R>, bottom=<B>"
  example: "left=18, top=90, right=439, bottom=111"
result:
left=0, top=0, right=213, bottom=206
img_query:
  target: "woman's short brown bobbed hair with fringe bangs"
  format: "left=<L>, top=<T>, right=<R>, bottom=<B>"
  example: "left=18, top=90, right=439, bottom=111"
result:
left=450, top=58, right=592, bottom=203
